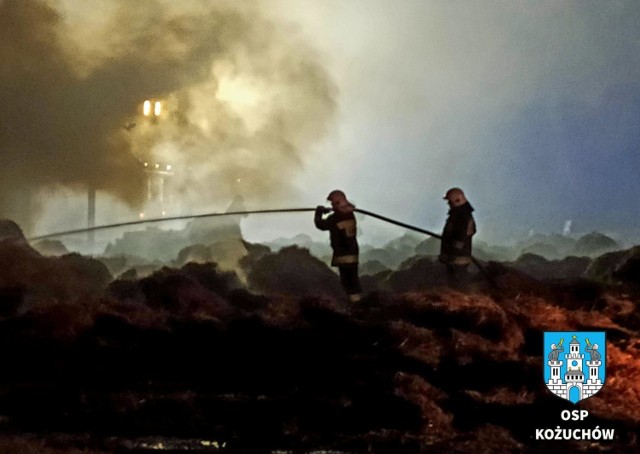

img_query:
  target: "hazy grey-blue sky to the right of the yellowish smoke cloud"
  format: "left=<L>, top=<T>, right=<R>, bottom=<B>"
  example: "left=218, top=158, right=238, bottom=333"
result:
left=262, top=1, right=640, bottom=245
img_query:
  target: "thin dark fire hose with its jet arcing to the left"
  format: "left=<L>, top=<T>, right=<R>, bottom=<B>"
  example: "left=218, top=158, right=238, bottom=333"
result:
left=28, top=208, right=497, bottom=287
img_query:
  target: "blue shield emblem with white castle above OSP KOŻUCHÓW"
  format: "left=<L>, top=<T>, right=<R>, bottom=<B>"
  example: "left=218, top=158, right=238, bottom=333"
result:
left=542, top=331, right=607, bottom=404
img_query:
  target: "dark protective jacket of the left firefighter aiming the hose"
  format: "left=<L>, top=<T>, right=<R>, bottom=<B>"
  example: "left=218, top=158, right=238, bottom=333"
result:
left=313, top=205, right=359, bottom=266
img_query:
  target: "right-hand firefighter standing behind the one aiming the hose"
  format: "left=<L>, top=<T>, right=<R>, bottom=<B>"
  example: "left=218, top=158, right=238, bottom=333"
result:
left=438, top=188, right=476, bottom=287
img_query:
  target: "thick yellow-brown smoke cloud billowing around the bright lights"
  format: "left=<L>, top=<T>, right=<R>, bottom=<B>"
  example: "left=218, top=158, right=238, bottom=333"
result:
left=0, top=0, right=335, bottom=232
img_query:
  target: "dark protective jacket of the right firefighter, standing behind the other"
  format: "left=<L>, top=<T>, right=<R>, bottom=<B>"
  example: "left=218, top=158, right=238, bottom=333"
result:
left=440, top=202, right=476, bottom=265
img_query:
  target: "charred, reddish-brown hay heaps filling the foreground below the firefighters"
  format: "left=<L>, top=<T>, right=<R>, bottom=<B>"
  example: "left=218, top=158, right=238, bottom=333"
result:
left=0, top=220, right=640, bottom=453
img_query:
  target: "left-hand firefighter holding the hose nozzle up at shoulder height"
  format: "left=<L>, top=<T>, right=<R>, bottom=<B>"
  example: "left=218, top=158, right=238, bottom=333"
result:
left=313, top=190, right=362, bottom=302
